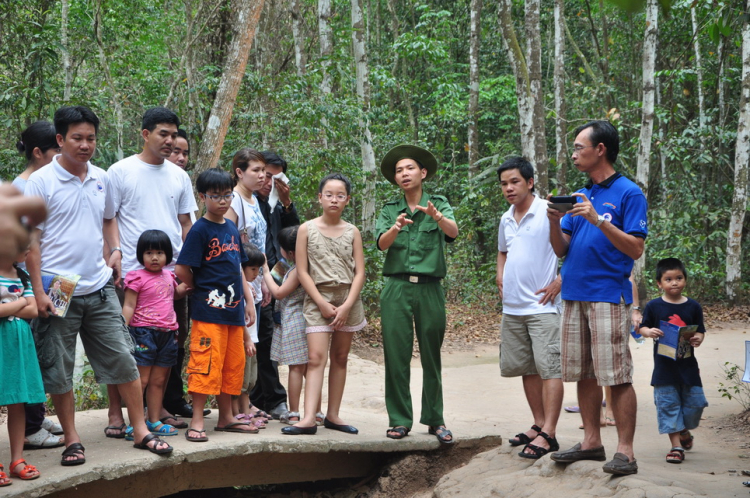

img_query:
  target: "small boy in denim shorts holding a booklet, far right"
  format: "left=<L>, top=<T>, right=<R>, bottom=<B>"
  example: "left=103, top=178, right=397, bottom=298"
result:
left=640, top=258, right=708, bottom=463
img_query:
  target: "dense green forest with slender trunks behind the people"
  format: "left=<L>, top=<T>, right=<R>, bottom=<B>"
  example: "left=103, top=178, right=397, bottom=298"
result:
left=0, top=0, right=750, bottom=312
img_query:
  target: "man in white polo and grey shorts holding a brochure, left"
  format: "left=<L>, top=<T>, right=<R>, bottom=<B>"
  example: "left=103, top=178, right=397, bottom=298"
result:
left=25, top=106, right=172, bottom=466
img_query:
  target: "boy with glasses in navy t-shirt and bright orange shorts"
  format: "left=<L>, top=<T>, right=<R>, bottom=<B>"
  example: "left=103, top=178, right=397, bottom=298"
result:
left=175, top=168, right=258, bottom=442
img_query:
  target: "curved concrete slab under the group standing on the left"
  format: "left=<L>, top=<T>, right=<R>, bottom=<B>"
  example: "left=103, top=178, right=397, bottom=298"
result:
left=0, top=410, right=502, bottom=498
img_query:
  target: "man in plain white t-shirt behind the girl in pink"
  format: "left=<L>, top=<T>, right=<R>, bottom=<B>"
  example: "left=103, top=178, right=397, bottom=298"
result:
left=105, top=107, right=198, bottom=437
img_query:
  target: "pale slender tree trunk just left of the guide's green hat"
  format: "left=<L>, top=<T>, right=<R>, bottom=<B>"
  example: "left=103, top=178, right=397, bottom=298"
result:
left=352, top=0, right=376, bottom=240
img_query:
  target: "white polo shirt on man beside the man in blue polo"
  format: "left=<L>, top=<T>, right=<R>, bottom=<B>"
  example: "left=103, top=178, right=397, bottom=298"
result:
left=497, top=195, right=560, bottom=316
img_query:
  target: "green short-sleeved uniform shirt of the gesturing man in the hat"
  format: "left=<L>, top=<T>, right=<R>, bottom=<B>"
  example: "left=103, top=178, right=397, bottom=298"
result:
left=375, top=192, right=455, bottom=278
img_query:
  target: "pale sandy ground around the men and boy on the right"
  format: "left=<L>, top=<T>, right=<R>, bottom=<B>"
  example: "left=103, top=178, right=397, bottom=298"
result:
left=344, top=323, right=750, bottom=498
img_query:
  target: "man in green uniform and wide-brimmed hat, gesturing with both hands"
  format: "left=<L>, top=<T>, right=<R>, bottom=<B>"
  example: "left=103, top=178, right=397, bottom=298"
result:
left=375, top=145, right=458, bottom=444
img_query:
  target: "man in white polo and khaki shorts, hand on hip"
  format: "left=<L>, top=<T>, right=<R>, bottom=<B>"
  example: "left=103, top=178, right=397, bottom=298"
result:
left=497, top=157, right=563, bottom=459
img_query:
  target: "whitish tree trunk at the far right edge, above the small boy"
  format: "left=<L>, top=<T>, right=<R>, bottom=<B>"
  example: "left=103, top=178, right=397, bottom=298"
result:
left=726, top=4, right=750, bottom=304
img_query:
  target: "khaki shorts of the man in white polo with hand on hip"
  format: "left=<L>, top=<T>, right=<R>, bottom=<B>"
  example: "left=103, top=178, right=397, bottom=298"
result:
left=500, top=313, right=562, bottom=380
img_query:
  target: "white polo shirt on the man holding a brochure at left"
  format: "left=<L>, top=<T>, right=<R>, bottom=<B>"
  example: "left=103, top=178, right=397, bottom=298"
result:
left=24, top=155, right=114, bottom=296
